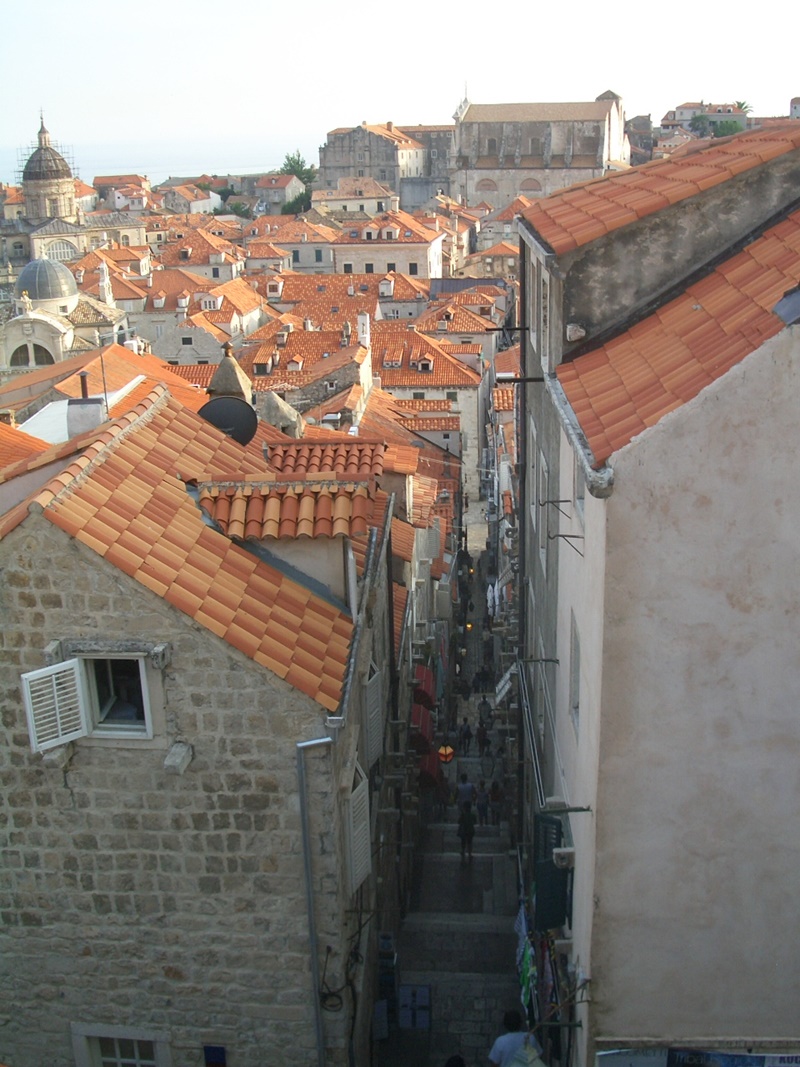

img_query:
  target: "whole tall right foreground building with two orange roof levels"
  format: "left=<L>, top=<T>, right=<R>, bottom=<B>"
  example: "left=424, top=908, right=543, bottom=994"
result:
left=515, top=123, right=800, bottom=1067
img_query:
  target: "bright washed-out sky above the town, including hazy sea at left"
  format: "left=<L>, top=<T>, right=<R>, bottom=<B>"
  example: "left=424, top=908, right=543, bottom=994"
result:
left=0, top=0, right=800, bottom=185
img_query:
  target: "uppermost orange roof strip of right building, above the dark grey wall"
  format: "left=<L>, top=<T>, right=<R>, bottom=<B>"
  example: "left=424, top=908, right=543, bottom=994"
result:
left=522, top=123, right=800, bottom=255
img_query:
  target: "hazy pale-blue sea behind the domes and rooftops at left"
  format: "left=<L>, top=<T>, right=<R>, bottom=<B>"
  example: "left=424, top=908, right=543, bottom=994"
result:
left=0, top=139, right=319, bottom=186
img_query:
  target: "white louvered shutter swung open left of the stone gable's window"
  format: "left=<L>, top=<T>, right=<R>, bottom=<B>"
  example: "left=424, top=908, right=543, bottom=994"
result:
left=22, top=659, right=90, bottom=752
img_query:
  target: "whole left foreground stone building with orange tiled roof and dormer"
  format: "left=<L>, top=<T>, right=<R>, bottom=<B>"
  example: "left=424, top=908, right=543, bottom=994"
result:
left=0, top=387, right=411, bottom=1067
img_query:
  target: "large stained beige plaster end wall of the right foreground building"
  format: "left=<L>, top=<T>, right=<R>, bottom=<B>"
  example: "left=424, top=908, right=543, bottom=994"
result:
left=591, top=328, right=800, bottom=1047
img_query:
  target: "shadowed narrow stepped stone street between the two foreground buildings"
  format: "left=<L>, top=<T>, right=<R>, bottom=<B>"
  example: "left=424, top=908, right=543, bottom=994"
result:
left=372, top=527, right=519, bottom=1067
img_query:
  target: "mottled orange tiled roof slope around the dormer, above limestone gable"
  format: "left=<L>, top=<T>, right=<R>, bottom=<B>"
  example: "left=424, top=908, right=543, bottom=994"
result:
left=26, top=389, right=353, bottom=712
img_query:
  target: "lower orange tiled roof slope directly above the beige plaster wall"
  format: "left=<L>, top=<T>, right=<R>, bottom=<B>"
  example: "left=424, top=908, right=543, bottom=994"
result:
left=558, top=205, right=800, bottom=466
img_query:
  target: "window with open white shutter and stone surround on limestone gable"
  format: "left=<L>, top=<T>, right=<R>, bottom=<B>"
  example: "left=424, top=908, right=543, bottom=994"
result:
left=21, top=642, right=169, bottom=752
